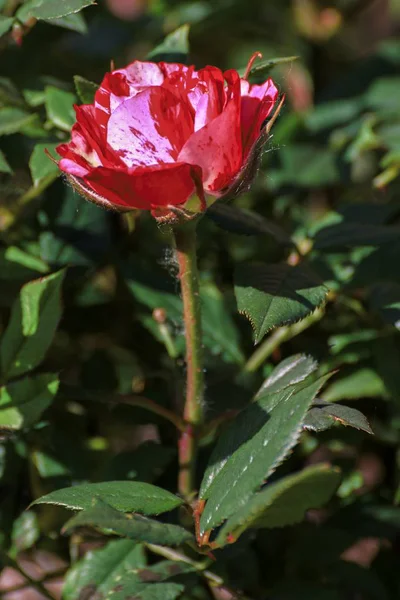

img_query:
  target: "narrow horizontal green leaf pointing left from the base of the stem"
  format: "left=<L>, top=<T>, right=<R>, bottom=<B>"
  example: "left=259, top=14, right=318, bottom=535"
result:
left=33, top=481, right=183, bottom=515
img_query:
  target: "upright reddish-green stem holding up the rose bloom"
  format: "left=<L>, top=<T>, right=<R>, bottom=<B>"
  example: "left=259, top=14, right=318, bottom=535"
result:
left=174, top=221, right=204, bottom=500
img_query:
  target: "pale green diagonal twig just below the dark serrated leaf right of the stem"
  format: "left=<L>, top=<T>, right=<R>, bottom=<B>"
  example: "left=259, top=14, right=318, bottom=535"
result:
left=243, top=308, right=325, bottom=373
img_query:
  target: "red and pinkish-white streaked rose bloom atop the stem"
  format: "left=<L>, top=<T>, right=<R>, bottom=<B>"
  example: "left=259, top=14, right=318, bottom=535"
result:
left=57, top=53, right=278, bottom=220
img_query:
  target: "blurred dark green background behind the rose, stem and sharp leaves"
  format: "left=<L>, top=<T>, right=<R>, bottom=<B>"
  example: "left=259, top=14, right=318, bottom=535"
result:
left=0, top=0, right=400, bottom=600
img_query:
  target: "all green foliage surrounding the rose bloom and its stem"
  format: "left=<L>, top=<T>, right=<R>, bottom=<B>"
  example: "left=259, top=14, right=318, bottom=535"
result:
left=0, top=0, right=400, bottom=600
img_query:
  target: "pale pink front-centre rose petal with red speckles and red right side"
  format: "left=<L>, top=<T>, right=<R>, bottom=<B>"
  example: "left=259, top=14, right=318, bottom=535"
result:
left=107, top=87, right=193, bottom=167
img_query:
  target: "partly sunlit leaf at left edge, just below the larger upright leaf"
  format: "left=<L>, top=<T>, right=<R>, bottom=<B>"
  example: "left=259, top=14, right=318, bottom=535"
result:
left=0, top=374, right=59, bottom=431
